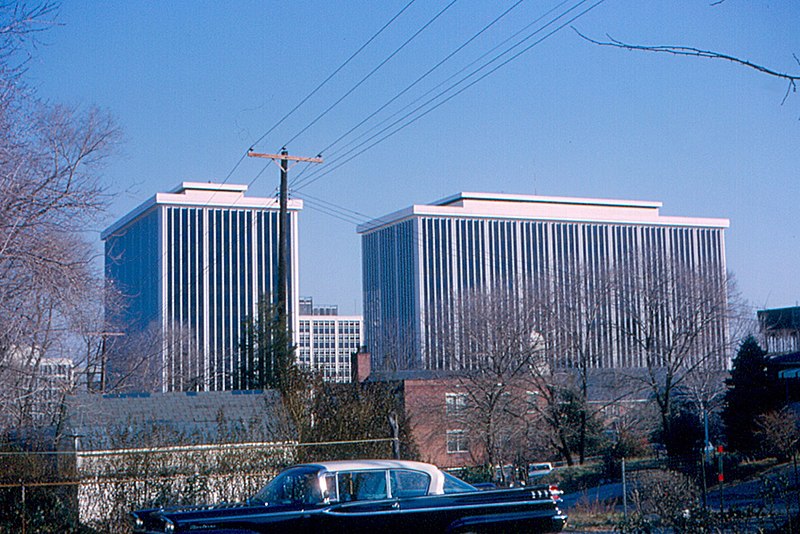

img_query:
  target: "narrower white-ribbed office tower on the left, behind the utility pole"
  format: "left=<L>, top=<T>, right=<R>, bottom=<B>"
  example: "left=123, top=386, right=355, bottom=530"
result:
left=101, top=182, right=302, bottom=391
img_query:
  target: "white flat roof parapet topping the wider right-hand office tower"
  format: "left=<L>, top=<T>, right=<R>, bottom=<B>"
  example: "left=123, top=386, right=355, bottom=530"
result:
left=357, top=192, right=730, bottom=234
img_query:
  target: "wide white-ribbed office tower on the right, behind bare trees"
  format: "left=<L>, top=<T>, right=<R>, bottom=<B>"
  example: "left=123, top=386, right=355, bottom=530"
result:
left=358, top=193, right=729, bottom=371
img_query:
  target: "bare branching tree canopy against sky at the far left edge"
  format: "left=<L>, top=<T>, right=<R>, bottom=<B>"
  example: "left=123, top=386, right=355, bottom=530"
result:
left=0, top=2, right=119, bottom=432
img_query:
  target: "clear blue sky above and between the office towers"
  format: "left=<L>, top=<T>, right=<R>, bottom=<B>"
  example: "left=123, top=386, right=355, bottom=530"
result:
left=28, top=0, right=800, bottom=313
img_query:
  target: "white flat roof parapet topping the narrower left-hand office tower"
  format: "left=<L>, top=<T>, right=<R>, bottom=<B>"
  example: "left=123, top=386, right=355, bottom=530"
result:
left=100, top=182, right=303, bottom=241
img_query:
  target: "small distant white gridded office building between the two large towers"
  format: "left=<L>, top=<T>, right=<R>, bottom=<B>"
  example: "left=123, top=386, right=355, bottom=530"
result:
left=297, top=306, right=364, bottom=382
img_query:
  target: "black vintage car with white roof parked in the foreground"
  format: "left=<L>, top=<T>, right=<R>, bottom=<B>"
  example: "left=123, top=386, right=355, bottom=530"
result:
left=132, top=460, right=567, bottom=534
